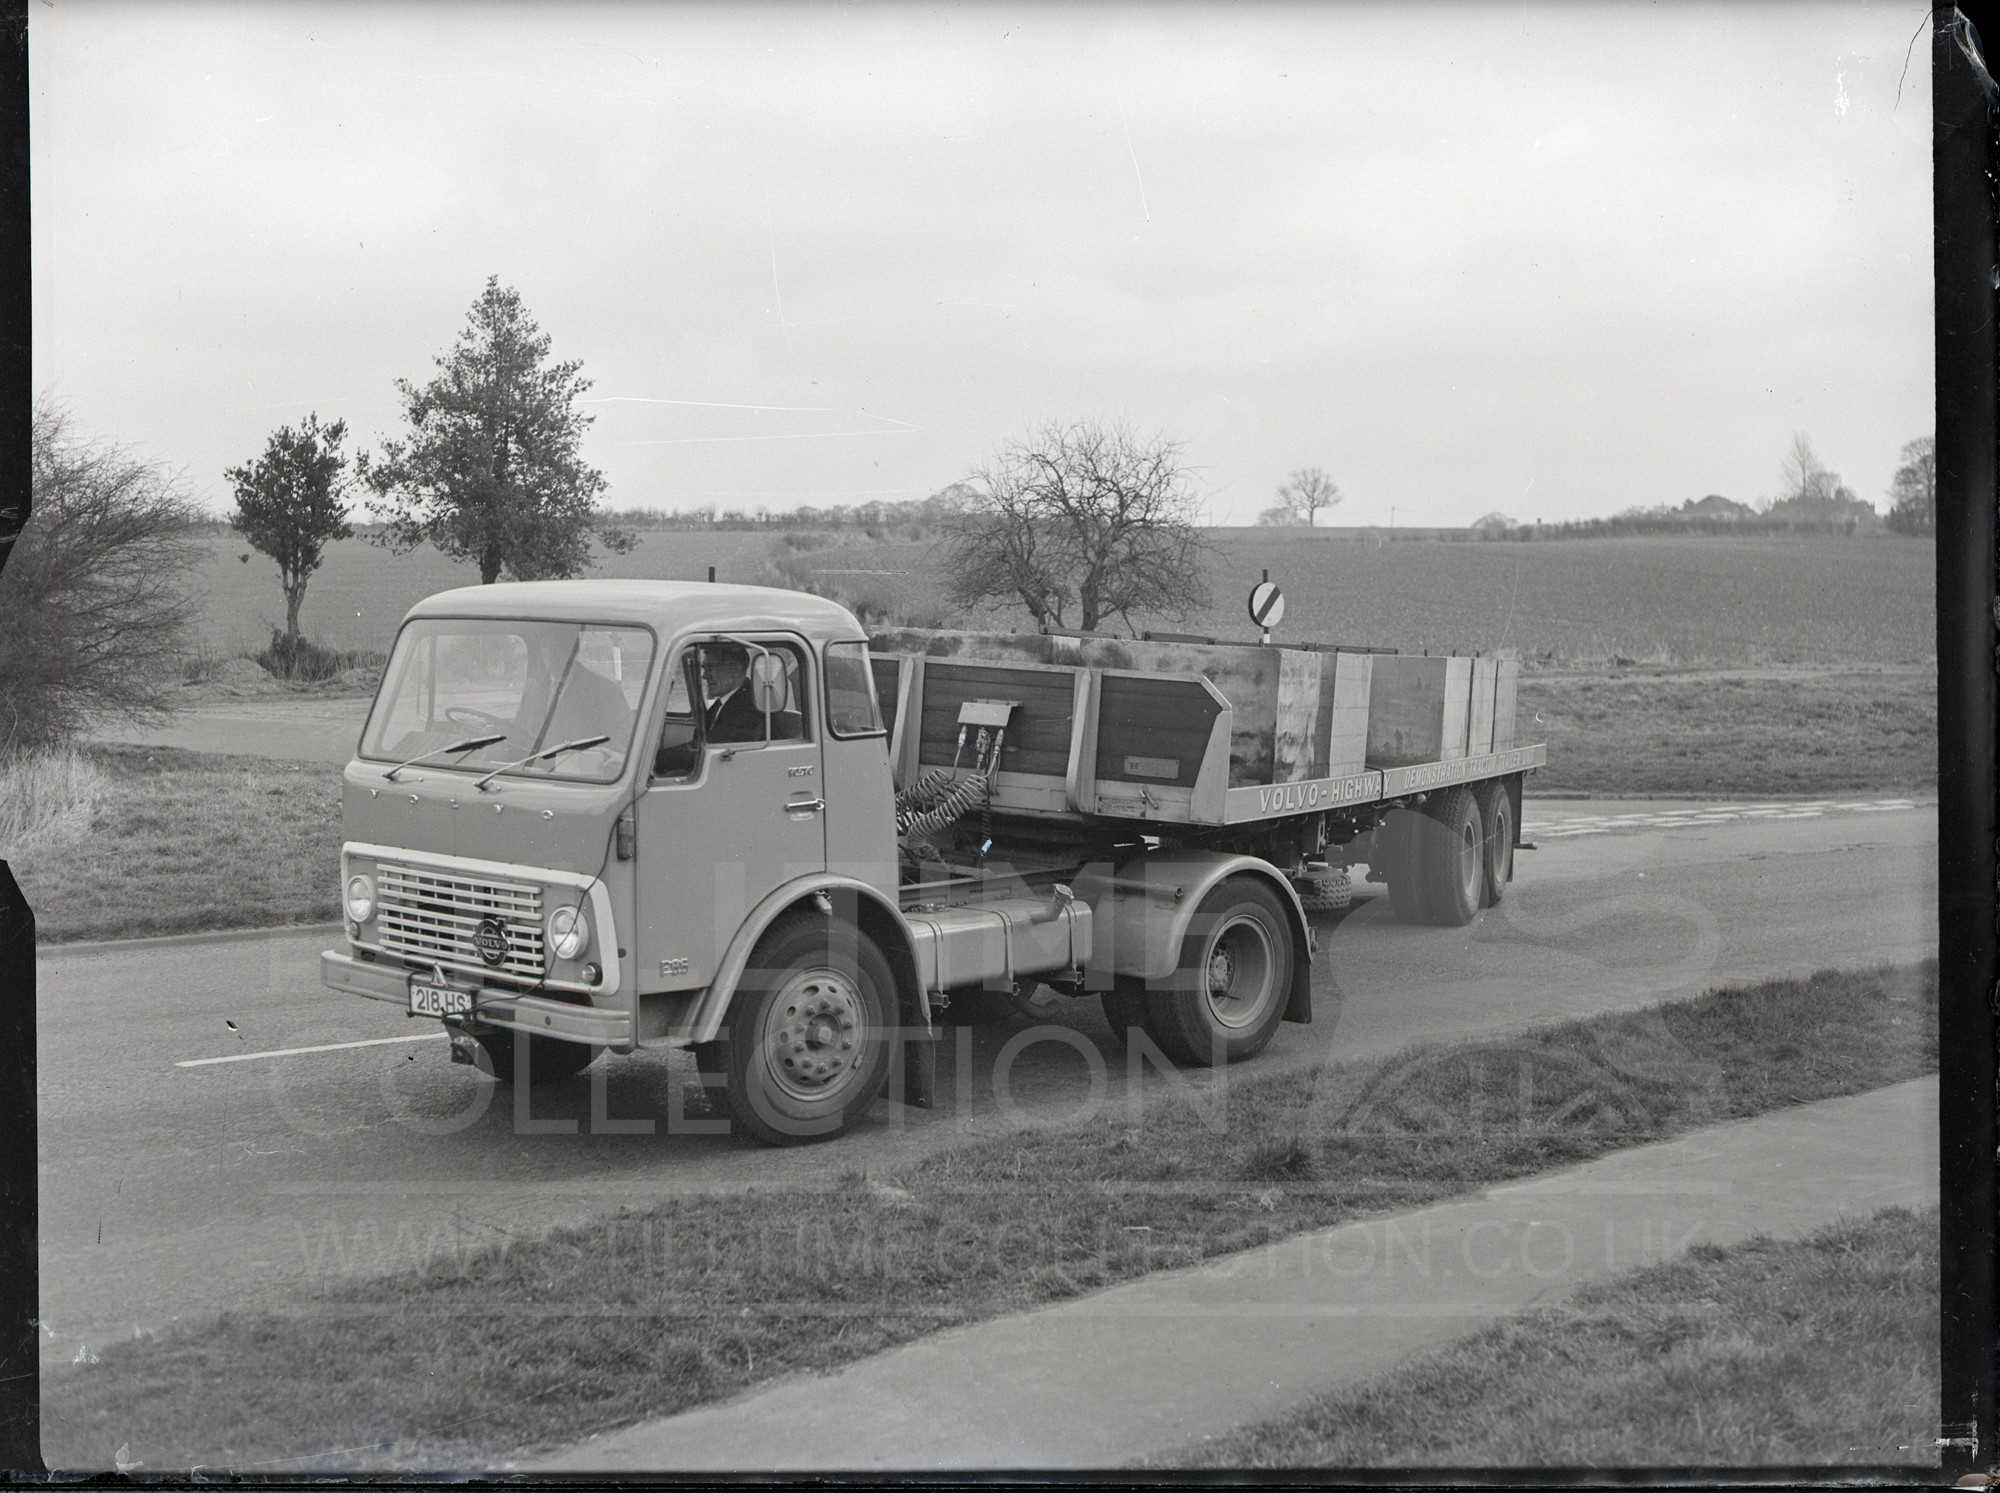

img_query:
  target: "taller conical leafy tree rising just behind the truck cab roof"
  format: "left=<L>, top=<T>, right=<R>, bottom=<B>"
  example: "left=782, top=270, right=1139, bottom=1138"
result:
left=354, top=276, right=634, bottom=584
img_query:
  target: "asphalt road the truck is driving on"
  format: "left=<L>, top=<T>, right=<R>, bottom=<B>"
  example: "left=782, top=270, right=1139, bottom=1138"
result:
left=36, top=801, right=1936, bottom=1361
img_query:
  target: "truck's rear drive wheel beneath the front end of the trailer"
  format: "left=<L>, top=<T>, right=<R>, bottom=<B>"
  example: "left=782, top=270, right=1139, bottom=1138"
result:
left=1144, top=877, right=1292, bottom=1067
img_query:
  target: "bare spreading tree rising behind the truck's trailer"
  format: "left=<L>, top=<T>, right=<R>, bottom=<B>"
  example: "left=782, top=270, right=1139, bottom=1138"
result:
left=942, top=420, right=1208, bottom=632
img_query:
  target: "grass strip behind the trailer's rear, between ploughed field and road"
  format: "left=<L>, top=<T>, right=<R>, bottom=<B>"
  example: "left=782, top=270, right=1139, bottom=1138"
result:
left=1516, top=668, right=1938, bottom=799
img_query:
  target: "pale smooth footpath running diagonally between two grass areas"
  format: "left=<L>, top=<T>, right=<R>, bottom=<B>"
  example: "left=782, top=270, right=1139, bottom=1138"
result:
left=528, top=1079, right=1938, bottom=1473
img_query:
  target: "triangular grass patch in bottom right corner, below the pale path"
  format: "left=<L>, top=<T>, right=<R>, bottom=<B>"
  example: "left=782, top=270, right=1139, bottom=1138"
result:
left=1148, top=1209, right=1940, bottom=1467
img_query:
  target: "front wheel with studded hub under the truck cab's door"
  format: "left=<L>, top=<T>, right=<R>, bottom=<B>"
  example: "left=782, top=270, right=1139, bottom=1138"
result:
left=724, top=917, right=896, bottom=1145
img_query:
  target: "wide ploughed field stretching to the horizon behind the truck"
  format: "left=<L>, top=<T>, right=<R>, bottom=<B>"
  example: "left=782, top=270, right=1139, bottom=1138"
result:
left=200, top=528, right=1936, bottom=666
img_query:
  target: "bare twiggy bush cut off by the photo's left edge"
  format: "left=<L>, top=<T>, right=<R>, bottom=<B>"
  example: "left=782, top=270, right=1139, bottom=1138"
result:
left=0, top=398, right=200, bottom=751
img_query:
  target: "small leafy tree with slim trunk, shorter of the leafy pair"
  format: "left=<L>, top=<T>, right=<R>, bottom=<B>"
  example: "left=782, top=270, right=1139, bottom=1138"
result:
left=222, top=414, right=354, bottom=658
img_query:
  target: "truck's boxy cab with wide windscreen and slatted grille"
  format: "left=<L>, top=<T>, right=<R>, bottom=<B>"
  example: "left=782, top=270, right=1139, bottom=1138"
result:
left=322, top=580, right=916, bottom=1136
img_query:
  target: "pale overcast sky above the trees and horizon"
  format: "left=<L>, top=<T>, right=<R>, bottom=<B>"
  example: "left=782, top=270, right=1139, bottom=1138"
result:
left=30, top=0, right=1932, bottom=524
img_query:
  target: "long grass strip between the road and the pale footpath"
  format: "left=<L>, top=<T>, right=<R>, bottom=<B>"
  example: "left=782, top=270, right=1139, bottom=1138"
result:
left=42, top=963, right=1936, bottom=1471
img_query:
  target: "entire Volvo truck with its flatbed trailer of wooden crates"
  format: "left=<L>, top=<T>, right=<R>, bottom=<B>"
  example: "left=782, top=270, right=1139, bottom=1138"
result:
left=322, top=580, right=1548, bottom=1145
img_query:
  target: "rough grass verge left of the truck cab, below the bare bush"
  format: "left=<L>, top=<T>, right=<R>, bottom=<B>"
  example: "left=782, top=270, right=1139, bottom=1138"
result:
left=12, top=747, right=340, bottom=943
